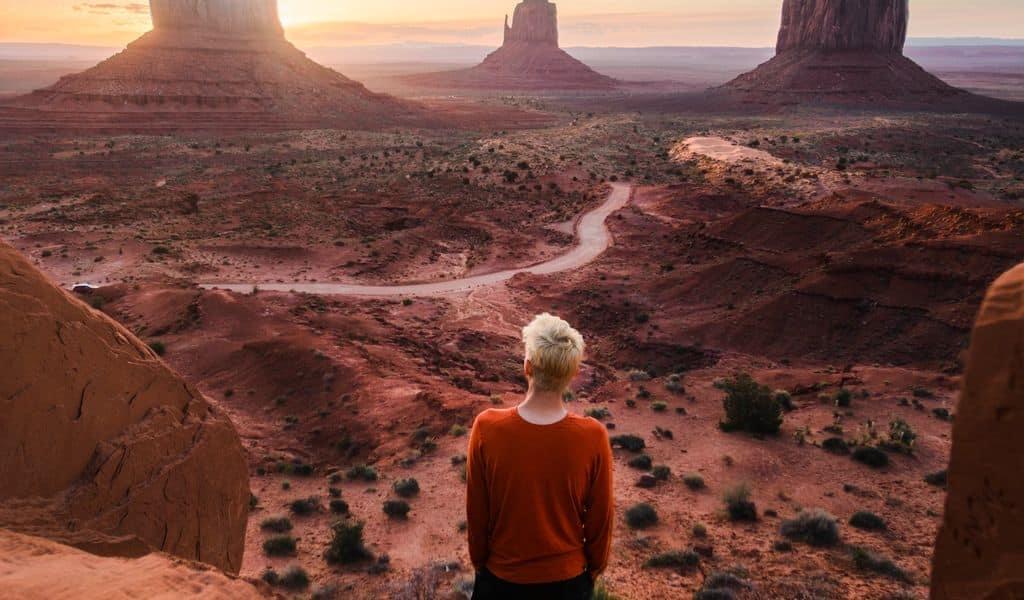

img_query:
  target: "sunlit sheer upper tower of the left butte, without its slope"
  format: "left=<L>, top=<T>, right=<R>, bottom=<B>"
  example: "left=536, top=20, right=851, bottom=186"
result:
left=150, top=0, right=284, bottom=36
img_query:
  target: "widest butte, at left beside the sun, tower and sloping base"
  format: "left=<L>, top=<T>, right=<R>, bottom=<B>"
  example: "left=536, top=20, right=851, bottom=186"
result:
left=0, top=0, right=421, bottom=130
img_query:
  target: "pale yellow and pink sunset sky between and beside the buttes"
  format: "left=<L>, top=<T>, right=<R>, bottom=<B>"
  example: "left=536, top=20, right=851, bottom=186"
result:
left=0, top=0, right=1024, bottom=46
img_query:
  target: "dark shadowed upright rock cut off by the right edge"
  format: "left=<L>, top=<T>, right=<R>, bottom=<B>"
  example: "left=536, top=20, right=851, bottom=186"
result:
left=932, top=264, right=1024, bottom=600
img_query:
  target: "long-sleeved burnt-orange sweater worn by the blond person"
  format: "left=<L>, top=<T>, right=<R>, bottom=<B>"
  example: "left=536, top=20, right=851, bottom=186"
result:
left=466, top=409, right=614, bottom=584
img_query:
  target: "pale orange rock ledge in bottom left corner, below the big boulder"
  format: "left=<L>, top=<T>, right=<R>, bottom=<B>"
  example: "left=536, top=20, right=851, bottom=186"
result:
left=0, top=529, right=272, bottom=600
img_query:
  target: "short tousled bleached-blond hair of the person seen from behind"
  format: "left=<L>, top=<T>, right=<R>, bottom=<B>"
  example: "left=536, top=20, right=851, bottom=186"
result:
left=522, top=312, right=585, bottom=391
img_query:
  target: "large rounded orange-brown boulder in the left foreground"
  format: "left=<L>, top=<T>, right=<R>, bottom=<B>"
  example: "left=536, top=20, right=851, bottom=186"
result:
left=0, top=243, right=250, bottom=572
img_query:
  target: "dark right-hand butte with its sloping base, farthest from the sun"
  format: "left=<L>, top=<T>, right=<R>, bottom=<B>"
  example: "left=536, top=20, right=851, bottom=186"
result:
left=724, top=0, right=969, bottom=105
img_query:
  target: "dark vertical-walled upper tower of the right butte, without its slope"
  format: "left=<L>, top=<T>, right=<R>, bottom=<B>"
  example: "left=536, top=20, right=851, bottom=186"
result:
left=776, top=0, right=910, bottom=53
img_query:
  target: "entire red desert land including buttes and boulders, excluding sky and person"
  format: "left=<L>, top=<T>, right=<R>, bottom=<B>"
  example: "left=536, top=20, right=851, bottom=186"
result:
left=0, top=0, right=1024, bottom=600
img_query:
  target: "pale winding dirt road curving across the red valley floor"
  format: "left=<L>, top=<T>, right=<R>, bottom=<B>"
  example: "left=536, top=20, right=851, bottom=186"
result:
left=200, top=183, right=633, bottom=298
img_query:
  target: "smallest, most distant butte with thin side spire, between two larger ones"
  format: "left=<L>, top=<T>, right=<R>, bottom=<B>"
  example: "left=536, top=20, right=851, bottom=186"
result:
left=407, top=0, right=618, bottom=90
